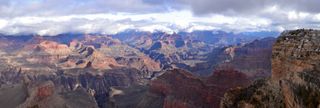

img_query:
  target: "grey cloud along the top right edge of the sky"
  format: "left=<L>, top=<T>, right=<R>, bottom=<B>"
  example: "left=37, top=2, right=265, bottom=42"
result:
left=177, top=0, right=320, bottom=15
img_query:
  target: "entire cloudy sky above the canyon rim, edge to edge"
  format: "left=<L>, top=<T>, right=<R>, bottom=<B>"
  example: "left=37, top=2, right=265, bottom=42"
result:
left=0, top=0, right=320, bottom=35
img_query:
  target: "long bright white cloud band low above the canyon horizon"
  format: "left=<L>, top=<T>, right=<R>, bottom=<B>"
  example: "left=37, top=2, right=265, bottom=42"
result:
left=0, top=10, right=282, bottom=35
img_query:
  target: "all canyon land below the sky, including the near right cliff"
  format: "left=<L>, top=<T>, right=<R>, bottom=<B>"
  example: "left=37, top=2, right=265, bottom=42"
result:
left=0, top=29, right=320, bottom=108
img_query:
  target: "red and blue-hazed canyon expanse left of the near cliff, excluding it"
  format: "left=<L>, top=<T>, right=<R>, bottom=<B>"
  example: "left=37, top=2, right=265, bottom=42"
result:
left=0, top=31, right=276, bottom=108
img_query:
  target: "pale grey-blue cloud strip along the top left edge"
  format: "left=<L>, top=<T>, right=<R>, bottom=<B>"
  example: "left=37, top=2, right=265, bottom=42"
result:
left=0, top=0, right=167, bottom=17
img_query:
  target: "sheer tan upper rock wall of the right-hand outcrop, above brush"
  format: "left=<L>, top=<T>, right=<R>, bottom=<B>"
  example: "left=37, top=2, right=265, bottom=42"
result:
left=272, top=30, right=320, bottom=80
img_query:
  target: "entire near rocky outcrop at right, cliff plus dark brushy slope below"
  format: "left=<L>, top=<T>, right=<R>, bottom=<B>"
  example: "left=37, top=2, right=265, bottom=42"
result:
left=221, top=30, right=320, bottom=108
